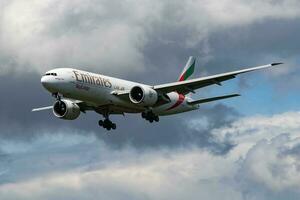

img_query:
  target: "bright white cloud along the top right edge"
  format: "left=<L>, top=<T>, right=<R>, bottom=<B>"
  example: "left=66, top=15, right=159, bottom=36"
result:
left=187, top=0, right=299, bottom=28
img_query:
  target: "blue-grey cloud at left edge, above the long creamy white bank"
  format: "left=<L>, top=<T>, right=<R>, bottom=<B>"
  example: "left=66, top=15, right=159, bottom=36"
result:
left=0, top=132, right=105, bottom=185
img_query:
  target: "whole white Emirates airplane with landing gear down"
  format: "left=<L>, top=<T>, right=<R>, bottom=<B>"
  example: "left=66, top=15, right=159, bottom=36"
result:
left=32, top=57, right=282, bottom=130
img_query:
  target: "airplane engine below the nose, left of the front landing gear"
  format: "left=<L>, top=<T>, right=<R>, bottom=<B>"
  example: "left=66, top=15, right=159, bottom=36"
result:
left=53, top=99, right=80, bottom=120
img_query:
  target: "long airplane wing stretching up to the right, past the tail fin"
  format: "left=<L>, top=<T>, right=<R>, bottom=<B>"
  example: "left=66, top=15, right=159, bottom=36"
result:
left=153, top=63, right=282, bottom=94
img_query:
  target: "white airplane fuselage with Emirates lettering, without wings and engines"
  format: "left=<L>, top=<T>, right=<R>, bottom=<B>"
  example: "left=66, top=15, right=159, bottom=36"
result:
left=41, top=68, right=199, bottom=116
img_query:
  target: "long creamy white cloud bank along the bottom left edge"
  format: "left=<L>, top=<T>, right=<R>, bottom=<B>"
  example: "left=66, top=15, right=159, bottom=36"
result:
left=0, top=142, right=239, bottom=199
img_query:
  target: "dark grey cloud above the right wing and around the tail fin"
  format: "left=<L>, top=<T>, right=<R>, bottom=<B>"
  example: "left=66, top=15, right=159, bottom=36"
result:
left=140, top=18, right=300, bottom=84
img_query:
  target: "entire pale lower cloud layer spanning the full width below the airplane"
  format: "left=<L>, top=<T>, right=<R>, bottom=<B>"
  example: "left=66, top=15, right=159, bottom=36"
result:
left=0, top=112, right=300, bottom=200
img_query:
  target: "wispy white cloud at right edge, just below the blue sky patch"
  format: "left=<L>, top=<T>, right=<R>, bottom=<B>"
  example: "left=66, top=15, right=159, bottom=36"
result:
left=212, top=112, right=300, bottom=146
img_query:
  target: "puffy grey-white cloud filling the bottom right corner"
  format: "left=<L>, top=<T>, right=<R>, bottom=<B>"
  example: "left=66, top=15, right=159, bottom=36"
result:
left=236, top=134, right=300, bottom=199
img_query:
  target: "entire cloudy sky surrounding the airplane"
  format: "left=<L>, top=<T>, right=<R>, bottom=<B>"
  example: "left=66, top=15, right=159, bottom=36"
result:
left=0, top=0, right=300, bottom=200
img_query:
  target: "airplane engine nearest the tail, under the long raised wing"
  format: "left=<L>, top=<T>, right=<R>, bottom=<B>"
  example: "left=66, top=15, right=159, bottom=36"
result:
left=129, top=86, right=158, bottom=106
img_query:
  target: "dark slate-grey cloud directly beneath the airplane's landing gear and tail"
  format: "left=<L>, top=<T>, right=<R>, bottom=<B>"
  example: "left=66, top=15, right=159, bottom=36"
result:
left=99, top=104, right=240, bottom=154
